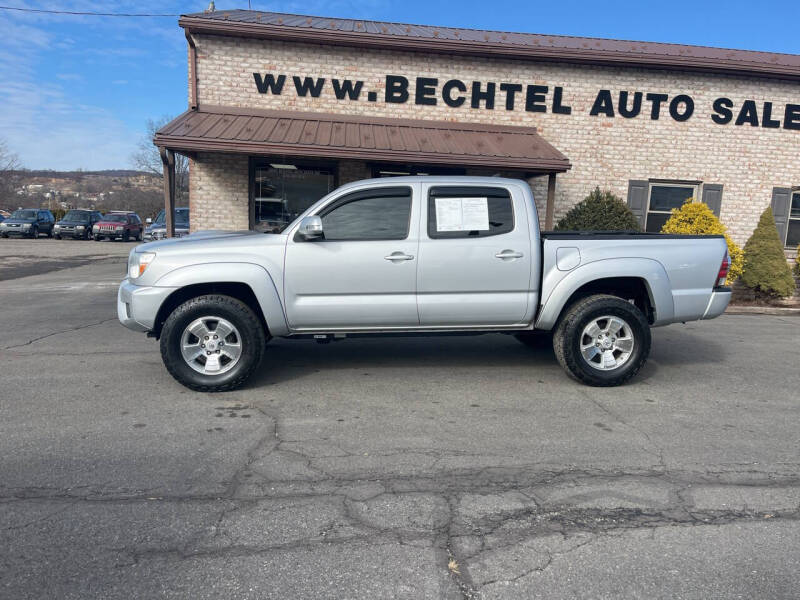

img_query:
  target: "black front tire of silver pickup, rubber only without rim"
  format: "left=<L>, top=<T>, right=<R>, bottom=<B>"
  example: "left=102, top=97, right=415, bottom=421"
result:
left=160, top=294, right=267, bottom=392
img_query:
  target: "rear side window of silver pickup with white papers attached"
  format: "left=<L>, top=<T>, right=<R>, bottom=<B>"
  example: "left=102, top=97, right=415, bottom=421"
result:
left=428, top=186, right=514, bottom=239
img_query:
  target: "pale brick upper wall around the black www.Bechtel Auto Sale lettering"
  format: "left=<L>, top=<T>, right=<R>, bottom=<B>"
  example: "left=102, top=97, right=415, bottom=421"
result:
left=193, top=35, right=800, bottom=242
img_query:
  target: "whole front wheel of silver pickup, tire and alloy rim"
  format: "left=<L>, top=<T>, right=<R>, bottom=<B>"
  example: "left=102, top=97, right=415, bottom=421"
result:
left=161, top=294, right=266, bottom=392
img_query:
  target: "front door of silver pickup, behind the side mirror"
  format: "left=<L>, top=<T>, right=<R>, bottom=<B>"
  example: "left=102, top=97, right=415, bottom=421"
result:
left=284, top=183, right=420, bottom=331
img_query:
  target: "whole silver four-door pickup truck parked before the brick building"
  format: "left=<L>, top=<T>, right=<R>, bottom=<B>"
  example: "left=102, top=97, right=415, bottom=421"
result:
left=117, top=177, right=731, bottom=392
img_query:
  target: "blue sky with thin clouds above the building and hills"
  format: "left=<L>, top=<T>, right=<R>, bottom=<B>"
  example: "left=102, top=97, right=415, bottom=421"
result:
left=0, top=0, right=800, bottom=170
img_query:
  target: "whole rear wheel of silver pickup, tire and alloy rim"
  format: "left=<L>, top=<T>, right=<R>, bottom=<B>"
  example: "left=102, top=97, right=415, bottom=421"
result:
left=553, top=294, right=651, bottom=387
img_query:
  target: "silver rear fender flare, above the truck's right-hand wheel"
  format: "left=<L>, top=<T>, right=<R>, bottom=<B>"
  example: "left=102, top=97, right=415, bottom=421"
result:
left=536, top=258, right=675, bottom=329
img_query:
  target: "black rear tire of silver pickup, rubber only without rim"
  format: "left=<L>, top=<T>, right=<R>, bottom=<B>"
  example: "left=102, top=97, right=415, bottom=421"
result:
left=553, top=294, right=651, bottom=387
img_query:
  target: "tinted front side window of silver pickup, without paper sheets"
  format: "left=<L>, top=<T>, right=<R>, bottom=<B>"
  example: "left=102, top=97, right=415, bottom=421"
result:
left=320, top=187, right=411, bottom=241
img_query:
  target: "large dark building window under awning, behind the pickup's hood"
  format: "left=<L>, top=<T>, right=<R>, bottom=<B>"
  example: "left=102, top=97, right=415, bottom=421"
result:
left=250, top=161, right=336, bottom=233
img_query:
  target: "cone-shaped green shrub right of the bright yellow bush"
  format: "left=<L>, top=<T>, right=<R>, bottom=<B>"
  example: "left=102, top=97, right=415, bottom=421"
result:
left=742, top=207, right=795, bottom=298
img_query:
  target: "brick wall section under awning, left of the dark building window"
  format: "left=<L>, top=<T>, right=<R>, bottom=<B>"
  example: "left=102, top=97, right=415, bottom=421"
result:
left=189, top=152, right=249, bottom=231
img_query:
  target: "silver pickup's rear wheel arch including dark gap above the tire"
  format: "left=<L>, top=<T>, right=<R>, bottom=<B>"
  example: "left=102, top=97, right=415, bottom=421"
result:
left=536, top=258, right=675, bottom=329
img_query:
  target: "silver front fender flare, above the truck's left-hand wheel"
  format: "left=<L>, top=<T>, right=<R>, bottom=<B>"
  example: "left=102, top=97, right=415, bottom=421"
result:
left=155, top=262, right=289, bottom=336
